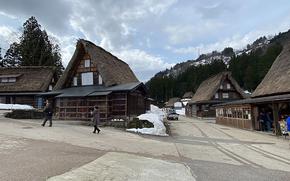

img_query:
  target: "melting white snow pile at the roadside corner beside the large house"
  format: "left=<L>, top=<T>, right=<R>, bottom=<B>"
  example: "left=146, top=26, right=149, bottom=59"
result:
left=126, top=105, right=168, bottom=136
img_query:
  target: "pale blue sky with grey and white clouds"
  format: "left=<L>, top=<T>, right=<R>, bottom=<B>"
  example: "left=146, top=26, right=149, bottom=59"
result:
left=0, top=0, right=290, bottom=81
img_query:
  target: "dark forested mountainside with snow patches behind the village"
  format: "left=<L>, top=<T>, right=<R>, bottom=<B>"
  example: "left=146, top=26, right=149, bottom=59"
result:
left=146, top=30, right=290, bottom=104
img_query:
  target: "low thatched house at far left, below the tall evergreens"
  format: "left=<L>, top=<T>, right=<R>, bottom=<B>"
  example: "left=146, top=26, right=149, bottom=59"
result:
left=0, top=66, right=57, bottom=108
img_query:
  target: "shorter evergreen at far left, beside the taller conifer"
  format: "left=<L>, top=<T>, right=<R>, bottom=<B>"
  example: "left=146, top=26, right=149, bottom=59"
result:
left=2, top=42, right=21, bottom=67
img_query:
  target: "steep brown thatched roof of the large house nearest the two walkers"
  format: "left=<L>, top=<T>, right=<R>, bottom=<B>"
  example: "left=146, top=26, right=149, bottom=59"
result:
left=54, top=39, right=139, bottom=90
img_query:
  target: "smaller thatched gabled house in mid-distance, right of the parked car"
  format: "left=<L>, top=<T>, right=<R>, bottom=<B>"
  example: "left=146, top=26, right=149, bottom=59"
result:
left=186, top=72, right=246, bottom=117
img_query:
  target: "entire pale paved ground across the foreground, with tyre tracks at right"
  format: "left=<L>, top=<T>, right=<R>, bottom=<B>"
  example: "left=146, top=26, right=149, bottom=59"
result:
left=0, top=113, right=290, bottom=181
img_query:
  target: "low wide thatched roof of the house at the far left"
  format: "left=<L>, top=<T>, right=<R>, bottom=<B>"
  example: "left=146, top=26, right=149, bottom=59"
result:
left=0, top=66, right=55, bottom=93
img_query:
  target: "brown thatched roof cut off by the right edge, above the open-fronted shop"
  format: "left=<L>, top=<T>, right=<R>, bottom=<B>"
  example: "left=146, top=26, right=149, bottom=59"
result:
left=252, top=42, right=290, bottom=97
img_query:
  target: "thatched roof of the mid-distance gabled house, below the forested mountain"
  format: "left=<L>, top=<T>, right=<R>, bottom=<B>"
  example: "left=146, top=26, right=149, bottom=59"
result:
left=191, top=72, right=246, bottom=102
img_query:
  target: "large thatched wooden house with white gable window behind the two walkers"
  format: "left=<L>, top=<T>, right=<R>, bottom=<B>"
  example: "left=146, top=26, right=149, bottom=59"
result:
left=42, top=39, right=147, bottom=122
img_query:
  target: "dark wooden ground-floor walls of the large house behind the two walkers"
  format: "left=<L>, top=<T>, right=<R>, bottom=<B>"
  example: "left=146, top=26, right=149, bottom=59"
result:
left=55, top=91, right=146, bottom=122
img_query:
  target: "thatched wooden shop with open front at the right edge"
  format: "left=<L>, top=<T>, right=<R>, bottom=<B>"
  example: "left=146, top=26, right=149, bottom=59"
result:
left=217, top=42, right=290, bottom=134
